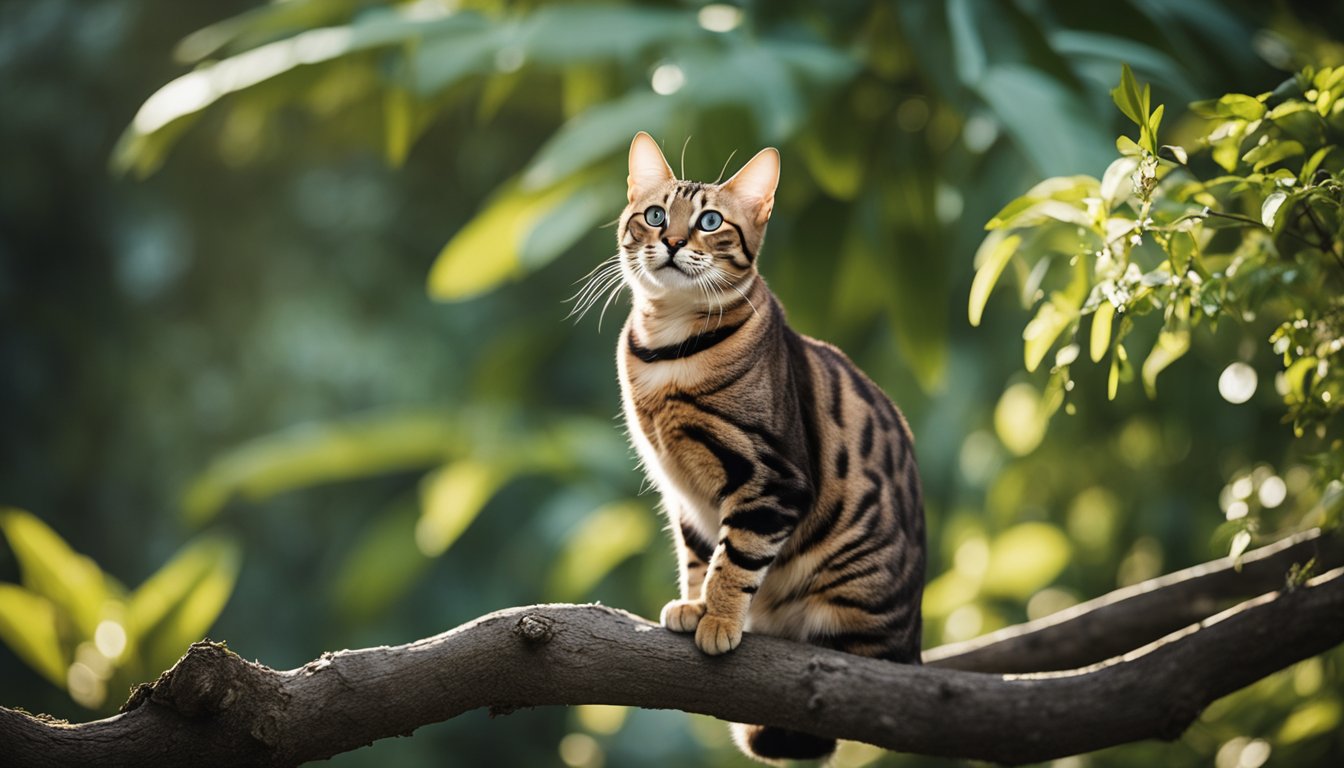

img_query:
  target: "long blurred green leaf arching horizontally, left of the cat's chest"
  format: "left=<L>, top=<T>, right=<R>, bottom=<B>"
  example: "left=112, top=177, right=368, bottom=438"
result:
left=183, top=409, right=456, bottom=523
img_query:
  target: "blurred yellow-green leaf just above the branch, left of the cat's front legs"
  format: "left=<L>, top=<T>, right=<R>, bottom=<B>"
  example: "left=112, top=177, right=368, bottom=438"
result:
left=547, top=500, right=655, bottom=603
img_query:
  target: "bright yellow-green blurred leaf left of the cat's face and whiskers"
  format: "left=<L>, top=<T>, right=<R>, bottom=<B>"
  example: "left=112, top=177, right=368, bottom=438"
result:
left=429, top=175, right=583, bottom=301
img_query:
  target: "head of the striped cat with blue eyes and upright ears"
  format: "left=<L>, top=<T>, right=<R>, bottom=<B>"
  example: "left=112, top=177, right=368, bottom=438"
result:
left=617, top=132, right=780, bottom=304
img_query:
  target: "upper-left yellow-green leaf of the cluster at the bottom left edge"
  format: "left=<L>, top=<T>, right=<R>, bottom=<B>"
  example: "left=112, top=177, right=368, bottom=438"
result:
left=0, top=508, right=109, bottom=638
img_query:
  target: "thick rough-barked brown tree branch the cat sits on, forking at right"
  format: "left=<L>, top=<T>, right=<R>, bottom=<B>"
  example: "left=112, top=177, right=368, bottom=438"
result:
left=0, top=537, right=1344, bottom=767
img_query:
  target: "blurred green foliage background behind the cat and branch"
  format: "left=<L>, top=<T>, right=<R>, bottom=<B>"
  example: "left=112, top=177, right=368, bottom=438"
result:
left=0, top=0, right=1344, bottom=768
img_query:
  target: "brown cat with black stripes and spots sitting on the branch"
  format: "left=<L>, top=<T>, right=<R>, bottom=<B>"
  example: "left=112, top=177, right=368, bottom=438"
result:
left=594, top=132, right=925, bottom=761
